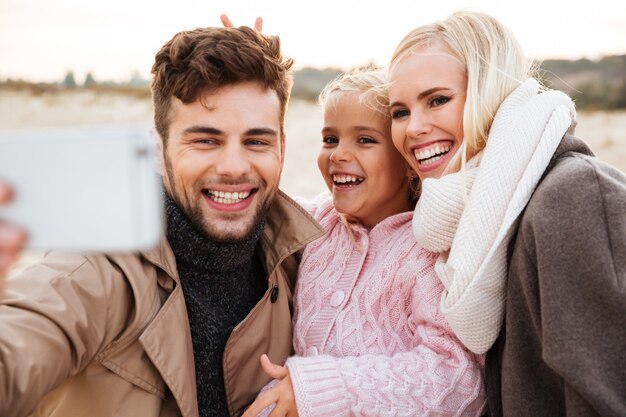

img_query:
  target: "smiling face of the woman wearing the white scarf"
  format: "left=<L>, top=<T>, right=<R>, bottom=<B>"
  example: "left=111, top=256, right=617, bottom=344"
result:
left=389, top=47, right=467, bottom=180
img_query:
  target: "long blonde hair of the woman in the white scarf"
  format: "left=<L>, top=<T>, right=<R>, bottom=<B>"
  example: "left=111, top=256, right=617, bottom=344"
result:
left=390, top=11, right=535, bottom=159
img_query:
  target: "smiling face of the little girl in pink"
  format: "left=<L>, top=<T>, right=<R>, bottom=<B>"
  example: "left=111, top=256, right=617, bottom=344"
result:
left=317, top=93, right=410, bottom=229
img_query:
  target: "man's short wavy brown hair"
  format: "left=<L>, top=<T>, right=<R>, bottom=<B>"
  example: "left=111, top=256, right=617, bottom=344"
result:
left=152, top=26, right=293, bottom=144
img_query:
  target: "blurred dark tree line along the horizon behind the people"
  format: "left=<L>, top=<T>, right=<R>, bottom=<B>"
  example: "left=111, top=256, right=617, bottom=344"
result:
left=0, top=55, right=626, bottom=110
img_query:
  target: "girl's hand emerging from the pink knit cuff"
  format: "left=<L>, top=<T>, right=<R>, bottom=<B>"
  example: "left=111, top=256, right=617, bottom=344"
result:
left=241, top=354, right=298, bottom=417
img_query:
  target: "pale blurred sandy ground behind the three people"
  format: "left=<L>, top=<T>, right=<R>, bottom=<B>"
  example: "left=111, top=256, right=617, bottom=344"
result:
left=0, top=90, right=626, bottom=274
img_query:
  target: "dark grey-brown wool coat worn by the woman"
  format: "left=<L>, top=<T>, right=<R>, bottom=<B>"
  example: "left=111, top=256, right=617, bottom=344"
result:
left=485, top=135, right=626, bottom=417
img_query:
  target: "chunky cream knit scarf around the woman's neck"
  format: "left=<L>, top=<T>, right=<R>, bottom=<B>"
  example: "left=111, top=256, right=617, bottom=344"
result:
left=413, top=79, right=576, bottom=353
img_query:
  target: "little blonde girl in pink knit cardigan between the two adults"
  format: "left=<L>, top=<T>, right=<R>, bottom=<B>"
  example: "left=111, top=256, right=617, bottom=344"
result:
left=244, top=70, right=485, bottom=417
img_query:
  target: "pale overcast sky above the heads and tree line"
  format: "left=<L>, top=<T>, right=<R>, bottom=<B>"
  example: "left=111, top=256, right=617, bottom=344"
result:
left=0, top=0, right=626, bottom=81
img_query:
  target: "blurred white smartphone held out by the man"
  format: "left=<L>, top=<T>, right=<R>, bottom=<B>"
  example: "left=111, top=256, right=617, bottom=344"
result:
left=0, top=127, right=164, bottom=251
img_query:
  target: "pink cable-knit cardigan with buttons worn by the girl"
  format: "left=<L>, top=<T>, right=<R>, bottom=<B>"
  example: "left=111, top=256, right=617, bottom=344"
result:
left=286, top=194, right=486, bottom=417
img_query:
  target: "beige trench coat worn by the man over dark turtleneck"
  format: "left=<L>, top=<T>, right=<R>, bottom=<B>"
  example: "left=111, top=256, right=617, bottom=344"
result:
left=0, top=193, right=322, bottom=417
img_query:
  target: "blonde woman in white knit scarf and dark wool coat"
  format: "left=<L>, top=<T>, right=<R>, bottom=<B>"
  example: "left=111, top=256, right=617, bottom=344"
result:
left=389, top=12, right=626, bottom=416
